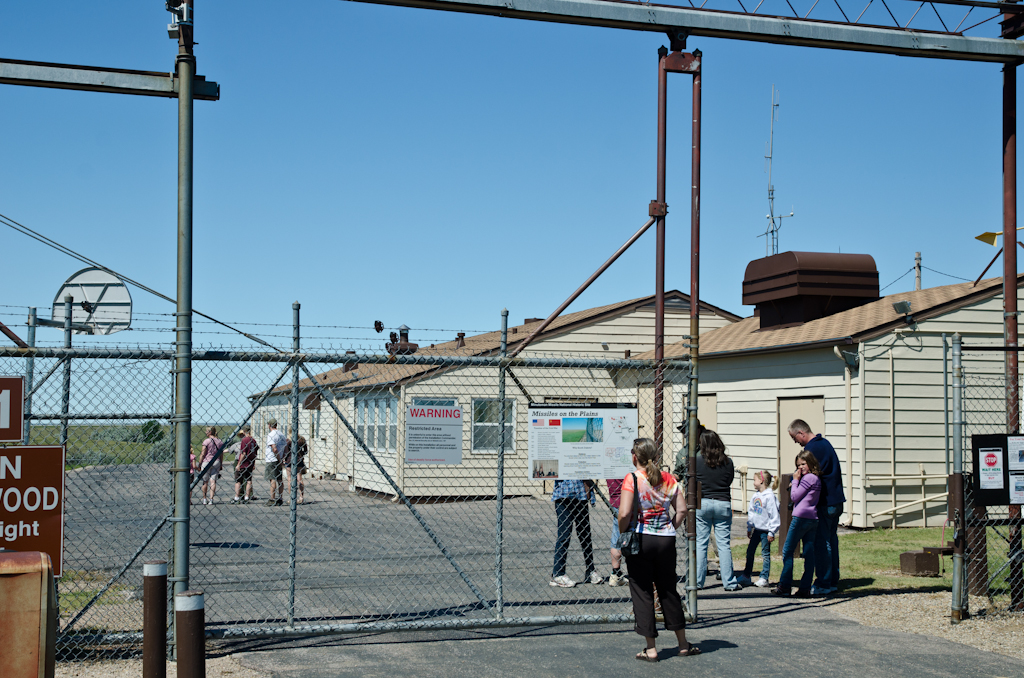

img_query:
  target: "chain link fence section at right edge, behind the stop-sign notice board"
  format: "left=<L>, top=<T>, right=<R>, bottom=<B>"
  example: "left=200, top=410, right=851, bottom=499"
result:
left=963, top=369, right=1024, bottom=612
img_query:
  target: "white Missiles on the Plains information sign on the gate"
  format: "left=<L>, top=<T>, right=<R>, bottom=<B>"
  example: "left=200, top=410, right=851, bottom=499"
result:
left=526, top=402, right=638, bottom=480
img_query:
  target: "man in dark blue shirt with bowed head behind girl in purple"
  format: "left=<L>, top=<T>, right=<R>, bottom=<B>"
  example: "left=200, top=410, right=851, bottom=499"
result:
left=788, top=419, right=846, bottom=595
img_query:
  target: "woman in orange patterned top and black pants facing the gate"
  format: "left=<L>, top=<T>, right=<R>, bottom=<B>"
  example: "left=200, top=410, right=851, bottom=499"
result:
left=618, top=438, right=700, bottom=662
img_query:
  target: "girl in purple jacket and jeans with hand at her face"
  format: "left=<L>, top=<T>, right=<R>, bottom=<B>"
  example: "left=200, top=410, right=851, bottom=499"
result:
left=771, top=450, right=821, bottom=598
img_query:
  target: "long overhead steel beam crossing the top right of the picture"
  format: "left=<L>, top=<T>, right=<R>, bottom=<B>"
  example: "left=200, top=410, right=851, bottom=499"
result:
left=344, top=0, right=1024, bottom=62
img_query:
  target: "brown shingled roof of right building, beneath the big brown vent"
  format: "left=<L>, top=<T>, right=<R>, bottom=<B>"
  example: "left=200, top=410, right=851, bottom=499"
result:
left=636, top=278, right=1011, bottom=359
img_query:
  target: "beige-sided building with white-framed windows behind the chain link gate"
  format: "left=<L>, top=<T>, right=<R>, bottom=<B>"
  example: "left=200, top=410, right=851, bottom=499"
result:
left=254, top=291, right=739, bottom=497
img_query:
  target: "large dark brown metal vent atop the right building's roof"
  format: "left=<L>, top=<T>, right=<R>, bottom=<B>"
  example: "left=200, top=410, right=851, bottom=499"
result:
left=743, top=252, right=879, bottom=330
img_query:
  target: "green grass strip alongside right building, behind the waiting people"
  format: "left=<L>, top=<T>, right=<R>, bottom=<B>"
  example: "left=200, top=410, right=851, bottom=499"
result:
left=732, top=527, right=952, bottom=594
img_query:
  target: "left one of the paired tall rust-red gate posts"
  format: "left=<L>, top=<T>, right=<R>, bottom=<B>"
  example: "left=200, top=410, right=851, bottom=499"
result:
left=654, top=47, right=671, bottom=466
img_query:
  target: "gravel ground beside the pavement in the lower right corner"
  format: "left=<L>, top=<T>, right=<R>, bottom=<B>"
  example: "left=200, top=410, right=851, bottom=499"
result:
left=819, top=591, right=1024, bottom=660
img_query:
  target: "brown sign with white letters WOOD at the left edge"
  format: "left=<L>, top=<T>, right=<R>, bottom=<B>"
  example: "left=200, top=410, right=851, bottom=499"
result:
left=0, top=446, right=65, bottom=577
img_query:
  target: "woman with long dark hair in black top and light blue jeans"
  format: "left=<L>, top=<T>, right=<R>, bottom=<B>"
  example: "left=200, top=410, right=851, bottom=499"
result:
left=696, top=429, right=739, bottom=591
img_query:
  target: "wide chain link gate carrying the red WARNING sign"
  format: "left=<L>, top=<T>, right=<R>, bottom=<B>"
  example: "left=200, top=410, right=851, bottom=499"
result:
left=0, top=349, right=688, bottom=659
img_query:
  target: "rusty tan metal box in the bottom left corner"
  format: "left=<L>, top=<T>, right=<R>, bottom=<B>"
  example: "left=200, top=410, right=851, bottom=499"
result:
left=0, top=551, right=57, bottom=678
